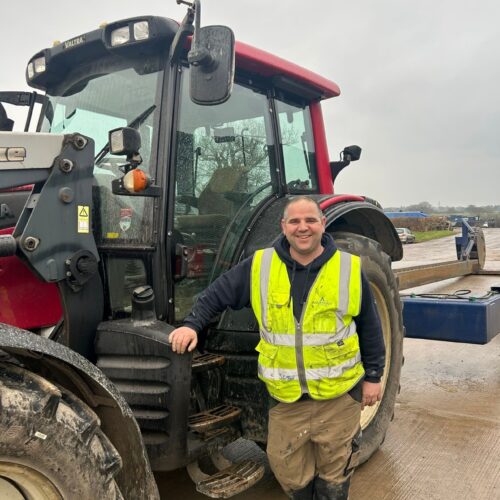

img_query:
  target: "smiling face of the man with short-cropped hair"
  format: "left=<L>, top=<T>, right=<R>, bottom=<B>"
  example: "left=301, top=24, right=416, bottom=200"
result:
left=281, top=200, right=326, bottom=257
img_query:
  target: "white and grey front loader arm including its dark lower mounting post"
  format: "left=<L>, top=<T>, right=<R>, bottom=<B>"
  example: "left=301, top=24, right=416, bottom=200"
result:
left=0, top=132, right=104, bottom=359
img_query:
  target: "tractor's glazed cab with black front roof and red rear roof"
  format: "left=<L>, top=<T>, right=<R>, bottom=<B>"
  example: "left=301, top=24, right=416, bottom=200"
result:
left=27, top=16, right=338, bottom=324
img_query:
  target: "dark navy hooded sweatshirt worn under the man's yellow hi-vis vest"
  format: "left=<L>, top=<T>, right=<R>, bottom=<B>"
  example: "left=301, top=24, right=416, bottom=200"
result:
left=184, top=234, right=385, bottom=382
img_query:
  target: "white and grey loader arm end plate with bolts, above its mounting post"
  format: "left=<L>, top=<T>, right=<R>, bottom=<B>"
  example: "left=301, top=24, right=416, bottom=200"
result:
left=0, top=133, right=99, bottom=284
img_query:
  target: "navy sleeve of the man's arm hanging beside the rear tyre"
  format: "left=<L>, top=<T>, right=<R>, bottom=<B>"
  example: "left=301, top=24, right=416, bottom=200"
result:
left=354, top=273, right=385, bottom=382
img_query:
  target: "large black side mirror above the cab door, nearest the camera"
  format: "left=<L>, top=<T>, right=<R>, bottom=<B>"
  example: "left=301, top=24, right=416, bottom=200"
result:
left=188, top=26, right=235, bottom=106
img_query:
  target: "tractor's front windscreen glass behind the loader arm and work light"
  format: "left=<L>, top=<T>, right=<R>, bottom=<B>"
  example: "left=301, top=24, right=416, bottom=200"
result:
left=40, top=65, right=163, bottom=246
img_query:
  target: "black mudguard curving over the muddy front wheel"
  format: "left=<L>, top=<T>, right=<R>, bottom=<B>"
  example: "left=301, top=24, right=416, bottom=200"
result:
left=0, top=323, right=160, bottom=500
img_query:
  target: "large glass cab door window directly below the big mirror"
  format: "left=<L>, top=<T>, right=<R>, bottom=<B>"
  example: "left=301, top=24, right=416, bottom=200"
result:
left=174, top=70, right=276, bottom=321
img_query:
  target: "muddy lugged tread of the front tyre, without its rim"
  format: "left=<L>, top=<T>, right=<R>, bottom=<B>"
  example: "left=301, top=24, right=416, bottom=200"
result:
left=0, top=362, right=122, bottom=499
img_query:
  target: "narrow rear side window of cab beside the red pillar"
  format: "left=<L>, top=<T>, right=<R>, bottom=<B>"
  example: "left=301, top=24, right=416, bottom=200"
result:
left=276, top=101, right=317, bottom=192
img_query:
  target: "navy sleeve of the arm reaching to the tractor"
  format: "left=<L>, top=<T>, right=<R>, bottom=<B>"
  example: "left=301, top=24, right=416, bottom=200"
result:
left=184, top=257, right=252, bottom=333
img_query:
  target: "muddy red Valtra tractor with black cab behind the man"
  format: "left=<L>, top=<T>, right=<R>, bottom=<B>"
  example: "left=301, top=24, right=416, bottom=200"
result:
left=0, top=1, right=403, bottom=499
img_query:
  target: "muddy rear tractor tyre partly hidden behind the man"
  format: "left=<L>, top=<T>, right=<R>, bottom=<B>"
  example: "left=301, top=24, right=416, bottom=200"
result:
left=333, top=232, right=404, bottom=463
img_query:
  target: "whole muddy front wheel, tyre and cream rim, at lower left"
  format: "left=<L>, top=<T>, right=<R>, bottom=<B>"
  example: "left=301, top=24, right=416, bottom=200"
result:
left=0, top=363, right=123, bottom=500
